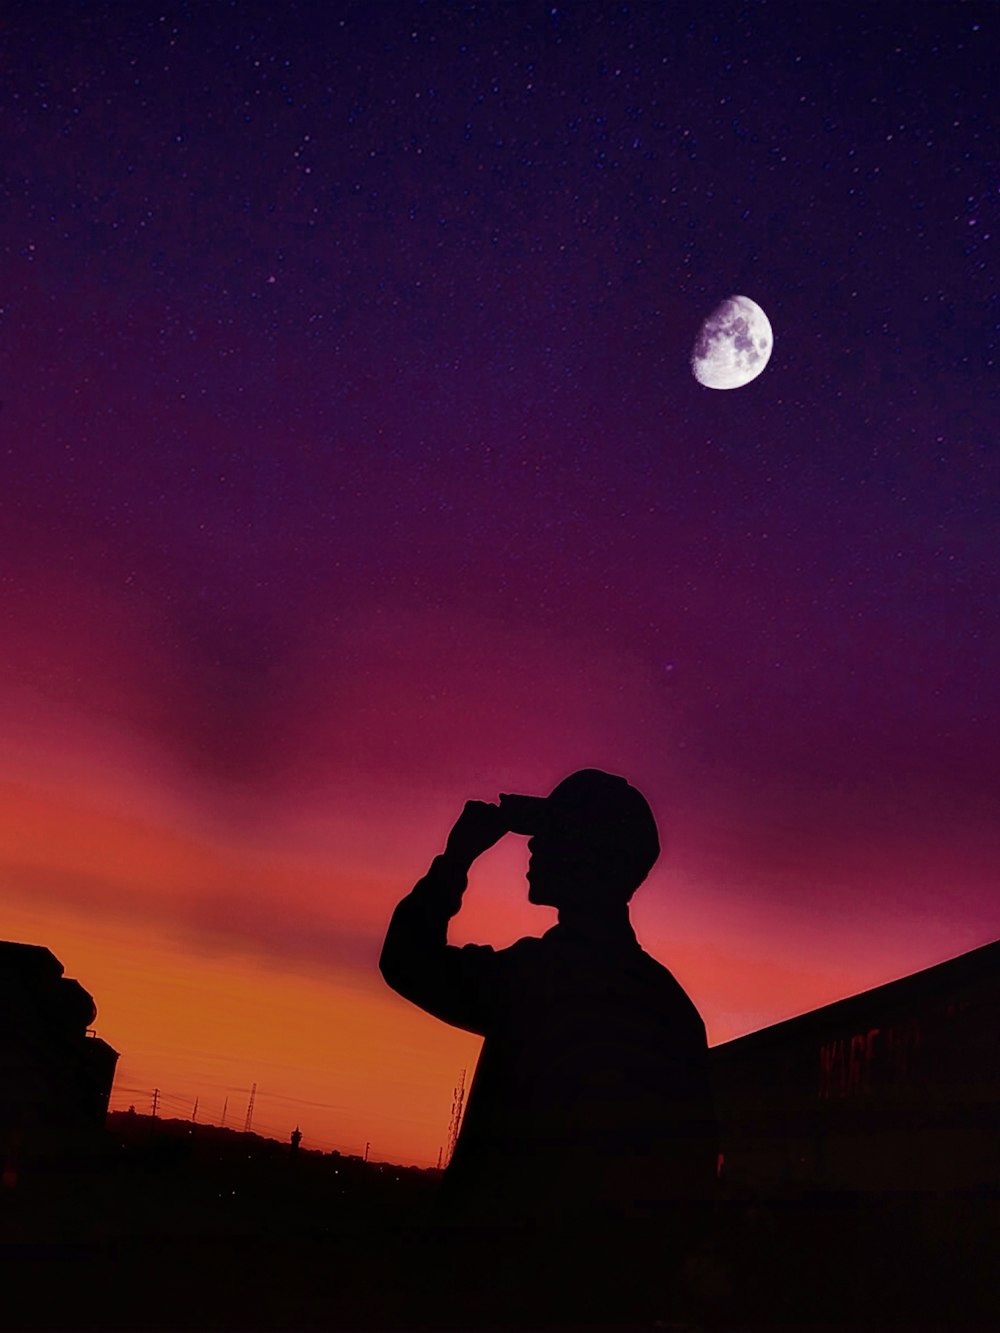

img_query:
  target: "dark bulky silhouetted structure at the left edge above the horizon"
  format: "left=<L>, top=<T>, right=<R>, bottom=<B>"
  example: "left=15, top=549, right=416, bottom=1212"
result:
left=0, top=941, right=119, bottom=1185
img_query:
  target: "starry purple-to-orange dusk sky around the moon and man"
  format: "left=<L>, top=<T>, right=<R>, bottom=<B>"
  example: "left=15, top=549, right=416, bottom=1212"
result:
left=0, top=0, right=1000, bottom=1165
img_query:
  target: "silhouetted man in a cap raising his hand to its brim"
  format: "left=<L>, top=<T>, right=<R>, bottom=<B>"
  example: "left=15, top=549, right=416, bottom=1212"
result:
left=380, top=769, right=716, bottom=1317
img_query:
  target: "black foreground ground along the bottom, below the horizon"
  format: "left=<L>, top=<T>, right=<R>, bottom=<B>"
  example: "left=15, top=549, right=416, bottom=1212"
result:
left=0, top=1125, right=1000, bottom=1330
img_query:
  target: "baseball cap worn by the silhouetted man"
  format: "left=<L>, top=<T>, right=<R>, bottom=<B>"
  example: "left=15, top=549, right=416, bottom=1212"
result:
left=500, top=768, right=660, bottom=884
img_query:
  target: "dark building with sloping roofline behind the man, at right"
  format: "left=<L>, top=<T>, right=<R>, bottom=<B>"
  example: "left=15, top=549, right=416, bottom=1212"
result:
left=711, top=941, right=1000, bottom=1196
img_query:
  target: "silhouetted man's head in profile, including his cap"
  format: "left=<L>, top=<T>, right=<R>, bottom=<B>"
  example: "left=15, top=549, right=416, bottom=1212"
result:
left=500, top=768, right=660, bottom=908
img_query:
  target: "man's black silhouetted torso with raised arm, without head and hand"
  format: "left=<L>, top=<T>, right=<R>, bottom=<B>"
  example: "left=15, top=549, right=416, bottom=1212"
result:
left=381, top=857, right=715, bottom=1228
